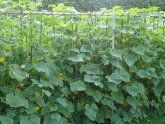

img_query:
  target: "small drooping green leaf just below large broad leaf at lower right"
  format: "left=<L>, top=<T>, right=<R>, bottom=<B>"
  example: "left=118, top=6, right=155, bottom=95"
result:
left=127, top=96, right=139, bottom=109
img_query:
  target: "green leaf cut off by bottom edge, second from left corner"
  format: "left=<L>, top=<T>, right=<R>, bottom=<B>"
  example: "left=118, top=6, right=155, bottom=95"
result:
left=20, top=115, right=40, bottom=124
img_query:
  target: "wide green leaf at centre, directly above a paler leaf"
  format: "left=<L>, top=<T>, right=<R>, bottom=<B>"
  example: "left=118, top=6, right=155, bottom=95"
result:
left=80, top=64, right=103, bottom=75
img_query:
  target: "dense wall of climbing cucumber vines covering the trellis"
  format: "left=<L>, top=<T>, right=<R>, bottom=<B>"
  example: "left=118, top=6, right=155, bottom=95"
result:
left=0, top=3, right=165, bottom=124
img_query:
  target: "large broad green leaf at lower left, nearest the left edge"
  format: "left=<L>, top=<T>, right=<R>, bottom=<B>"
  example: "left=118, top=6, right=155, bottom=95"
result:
left=6, top=90, right=28, bottom=108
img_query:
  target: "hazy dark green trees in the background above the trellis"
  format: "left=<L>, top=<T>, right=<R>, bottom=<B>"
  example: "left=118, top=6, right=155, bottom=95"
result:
left=42, top=0, right=165, bottom=11
